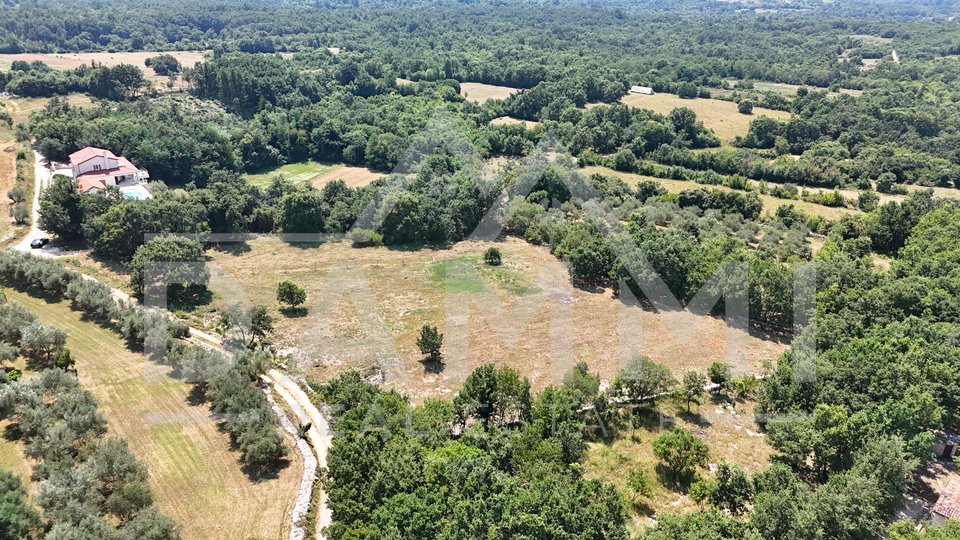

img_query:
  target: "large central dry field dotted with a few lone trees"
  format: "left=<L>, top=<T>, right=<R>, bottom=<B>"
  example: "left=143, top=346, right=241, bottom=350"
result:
left=209, top=237, right=785, bottom=401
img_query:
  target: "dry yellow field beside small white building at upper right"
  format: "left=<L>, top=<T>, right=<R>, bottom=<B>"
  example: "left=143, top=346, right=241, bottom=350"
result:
left=620, top=94, right=790, bottom=142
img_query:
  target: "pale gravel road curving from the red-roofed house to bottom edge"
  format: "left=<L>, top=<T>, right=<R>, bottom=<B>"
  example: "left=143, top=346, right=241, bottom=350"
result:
left=13, top=150, right=333, bottom=540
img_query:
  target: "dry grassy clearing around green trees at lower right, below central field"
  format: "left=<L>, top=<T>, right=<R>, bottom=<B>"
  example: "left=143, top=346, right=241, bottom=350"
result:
left=583, top=396, right=772, bottom=532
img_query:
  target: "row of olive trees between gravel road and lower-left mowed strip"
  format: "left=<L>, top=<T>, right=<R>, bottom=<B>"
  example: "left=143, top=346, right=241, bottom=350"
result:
left=0, top=250, right=287, bottom=474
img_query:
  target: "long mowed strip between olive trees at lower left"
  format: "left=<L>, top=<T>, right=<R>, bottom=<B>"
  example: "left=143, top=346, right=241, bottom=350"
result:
left=6, top=290, right=302, bottom=539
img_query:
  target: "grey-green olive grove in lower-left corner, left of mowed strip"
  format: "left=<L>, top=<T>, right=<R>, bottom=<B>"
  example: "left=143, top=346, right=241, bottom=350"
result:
left=0, top=301, right=180, bottom=540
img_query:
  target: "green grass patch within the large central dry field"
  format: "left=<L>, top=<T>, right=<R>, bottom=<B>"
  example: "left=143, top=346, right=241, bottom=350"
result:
left=431, top=255, right=540, bottom=296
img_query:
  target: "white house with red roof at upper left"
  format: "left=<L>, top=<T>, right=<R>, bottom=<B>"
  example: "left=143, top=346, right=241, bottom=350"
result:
left=70, top=146, right=150, bottom=198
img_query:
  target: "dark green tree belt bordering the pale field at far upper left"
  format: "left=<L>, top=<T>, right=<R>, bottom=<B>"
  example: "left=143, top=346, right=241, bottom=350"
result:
left=0, top=60, right=148, bottom=100
